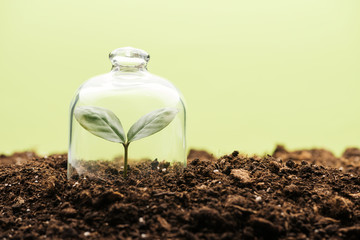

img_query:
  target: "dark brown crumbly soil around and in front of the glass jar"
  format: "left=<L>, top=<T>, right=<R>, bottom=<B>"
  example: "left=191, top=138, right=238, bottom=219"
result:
left=0, top=146, right=360, bottom=239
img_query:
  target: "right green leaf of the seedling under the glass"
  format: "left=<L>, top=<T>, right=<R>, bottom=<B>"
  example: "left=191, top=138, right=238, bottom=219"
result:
left=127, top=108, right=178, bottom=142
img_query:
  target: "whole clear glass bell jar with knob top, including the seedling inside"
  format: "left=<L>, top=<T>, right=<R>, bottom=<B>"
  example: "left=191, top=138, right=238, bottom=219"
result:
left=68, top=47, right=186, bottom=178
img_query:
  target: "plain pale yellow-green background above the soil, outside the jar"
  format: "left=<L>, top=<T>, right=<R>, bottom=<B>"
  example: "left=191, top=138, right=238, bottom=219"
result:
left=0, top=0, right=360, bottom=155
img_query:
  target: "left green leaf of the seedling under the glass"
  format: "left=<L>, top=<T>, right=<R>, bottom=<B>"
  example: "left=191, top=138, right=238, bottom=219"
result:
left=74, top=106, right=126, bottom=143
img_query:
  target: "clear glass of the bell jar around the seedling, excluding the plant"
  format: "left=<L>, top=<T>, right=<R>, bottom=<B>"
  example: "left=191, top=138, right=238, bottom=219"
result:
left=68, top=47, right=186, bottom=177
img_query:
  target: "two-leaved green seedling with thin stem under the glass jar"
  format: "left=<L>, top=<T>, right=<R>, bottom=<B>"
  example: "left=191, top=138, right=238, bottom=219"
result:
left=74, top=106, right=178, bottom=177
